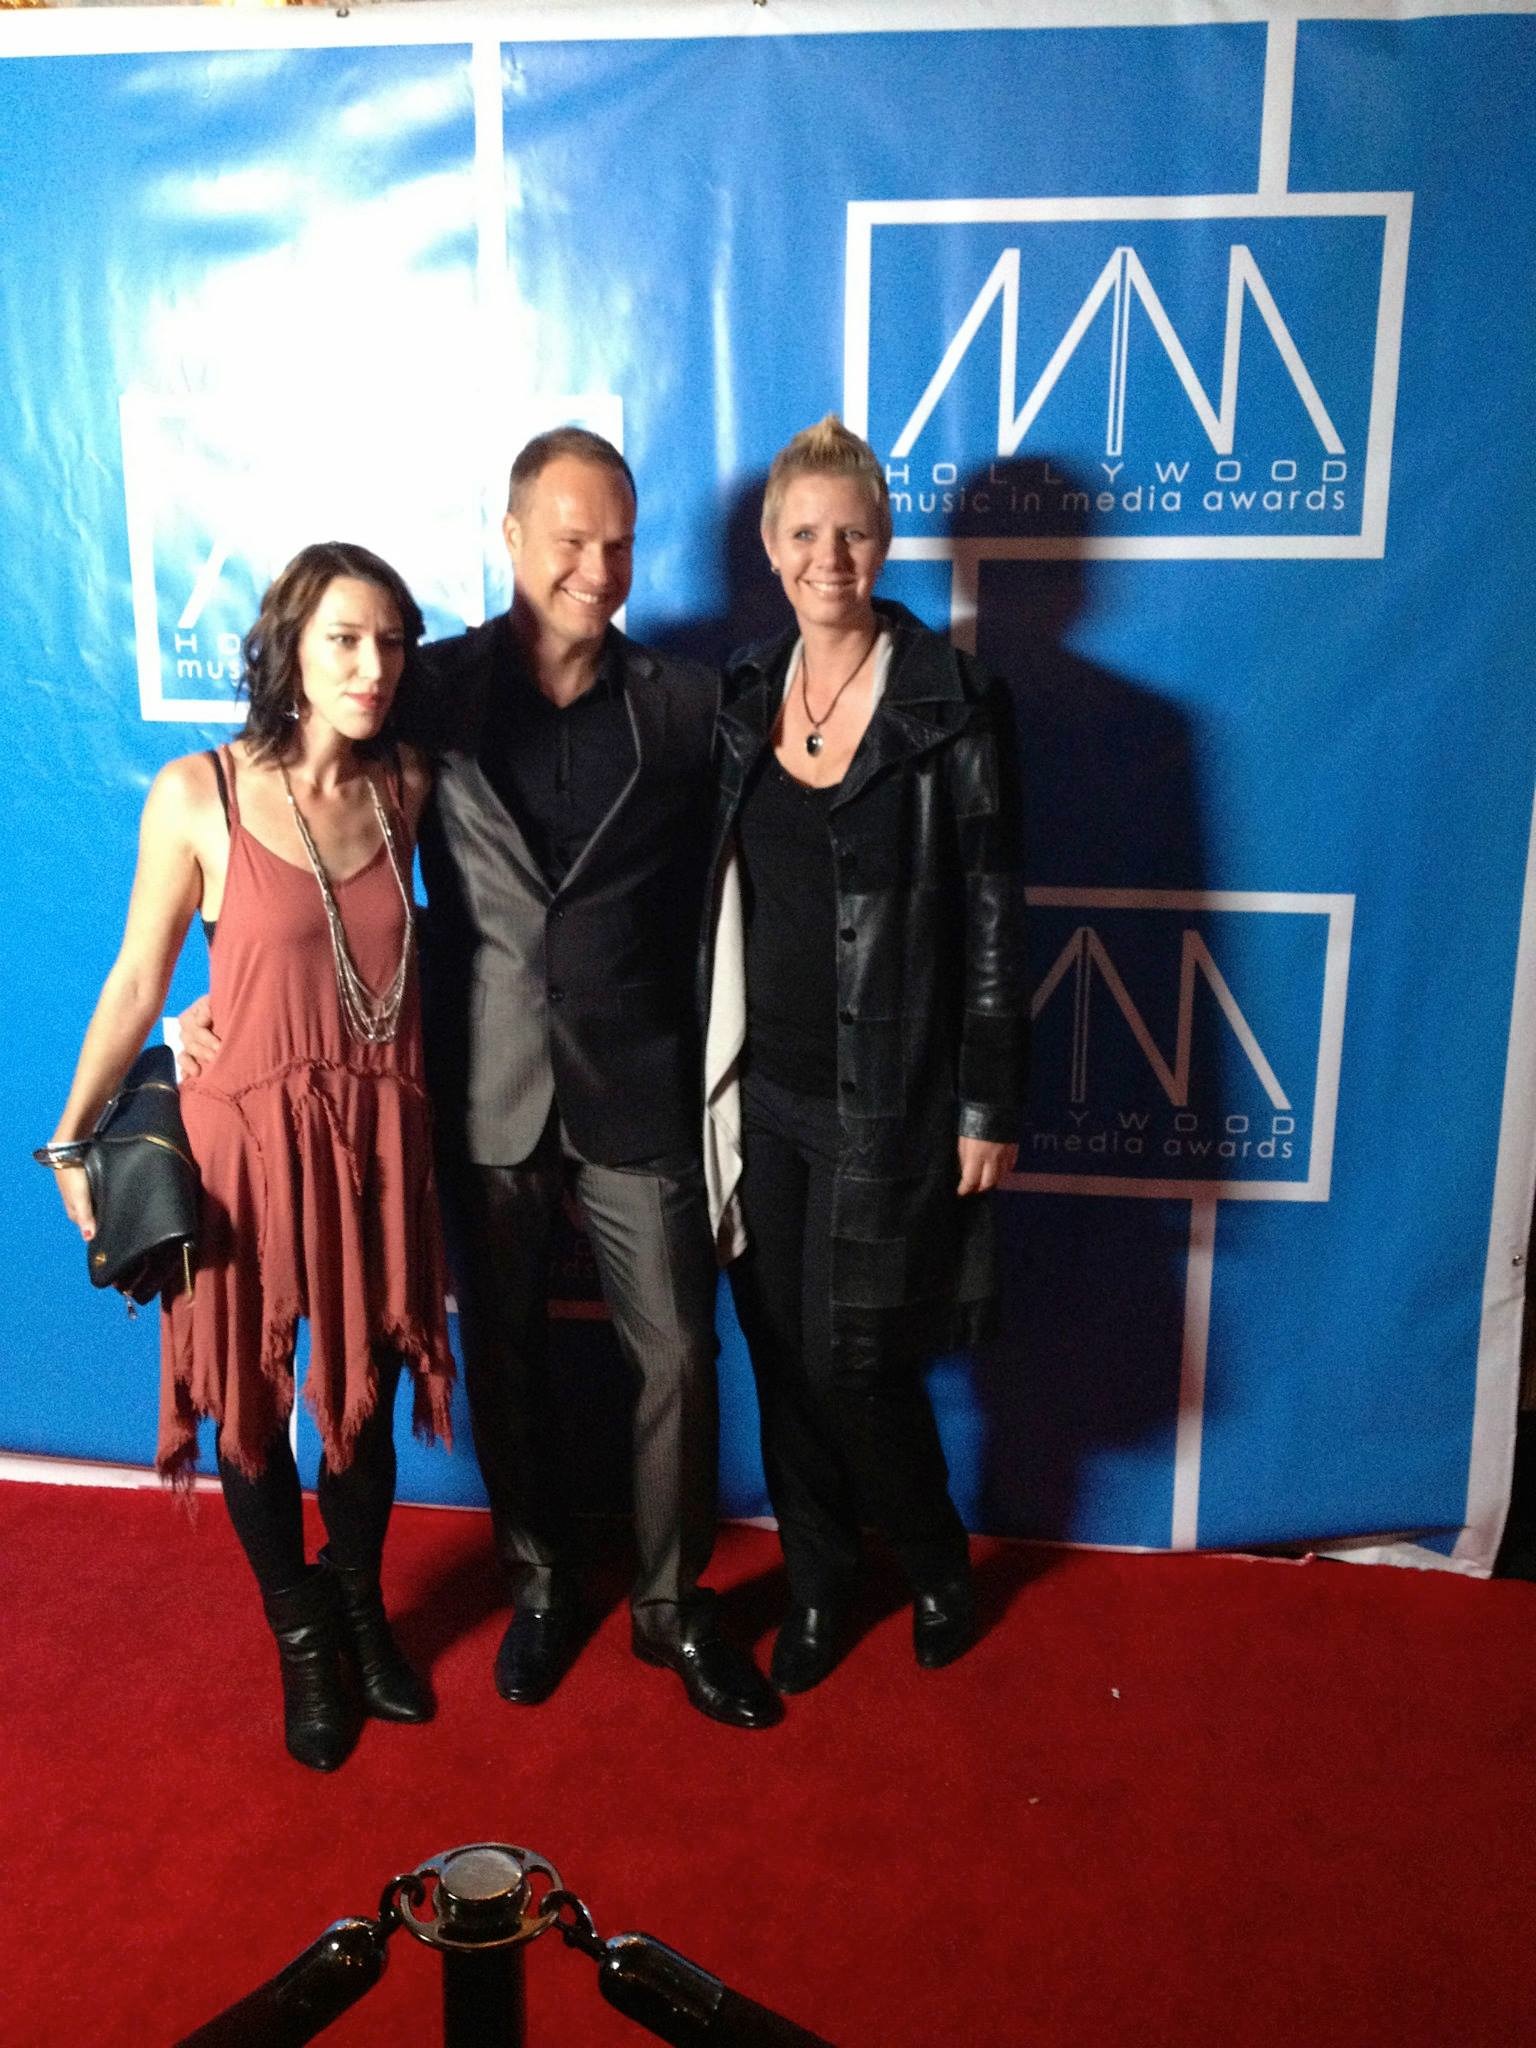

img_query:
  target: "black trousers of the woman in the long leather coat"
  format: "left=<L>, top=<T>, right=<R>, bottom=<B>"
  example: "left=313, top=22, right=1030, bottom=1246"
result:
left=731, top=1075, right=967, bottom=1608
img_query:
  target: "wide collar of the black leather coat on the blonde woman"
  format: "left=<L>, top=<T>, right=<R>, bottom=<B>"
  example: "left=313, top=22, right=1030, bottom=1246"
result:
left=721, top=598, right=971, bottom=807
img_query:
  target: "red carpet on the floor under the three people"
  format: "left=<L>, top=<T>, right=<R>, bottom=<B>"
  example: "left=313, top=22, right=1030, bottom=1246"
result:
left=0, top=1485, right=1536, bottom=2048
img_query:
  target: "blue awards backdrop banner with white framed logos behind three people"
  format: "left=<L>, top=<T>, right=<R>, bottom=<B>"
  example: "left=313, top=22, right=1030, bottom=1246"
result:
left=0, top=0, right=1536, bottom=1573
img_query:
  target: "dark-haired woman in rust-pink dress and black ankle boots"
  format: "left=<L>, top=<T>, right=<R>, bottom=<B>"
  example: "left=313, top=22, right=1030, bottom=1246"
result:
left=49, top=543, right=453, bottom=1772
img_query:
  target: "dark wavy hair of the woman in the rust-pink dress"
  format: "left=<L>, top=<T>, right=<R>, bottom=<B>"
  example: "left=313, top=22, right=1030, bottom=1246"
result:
left=240, top=541, right=426, bottom=756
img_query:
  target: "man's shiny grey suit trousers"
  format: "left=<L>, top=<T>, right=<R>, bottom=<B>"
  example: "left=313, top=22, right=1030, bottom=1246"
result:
left=442, top=1112, right=719, bottom=1638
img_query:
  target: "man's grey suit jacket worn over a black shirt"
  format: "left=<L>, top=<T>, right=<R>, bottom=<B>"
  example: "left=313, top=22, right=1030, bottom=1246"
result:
left=403, top=616, right=719, bottom=1165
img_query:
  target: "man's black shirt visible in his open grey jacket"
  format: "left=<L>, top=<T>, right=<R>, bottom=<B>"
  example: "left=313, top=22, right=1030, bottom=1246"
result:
left=481, top=633, right=635, bottom=889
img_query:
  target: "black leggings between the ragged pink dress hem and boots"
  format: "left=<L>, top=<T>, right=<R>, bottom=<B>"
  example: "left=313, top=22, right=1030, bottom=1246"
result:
left=219, top=1352, right=401, bottom=1593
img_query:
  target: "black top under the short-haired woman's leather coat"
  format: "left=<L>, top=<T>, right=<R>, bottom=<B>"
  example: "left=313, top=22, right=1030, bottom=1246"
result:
left=737, top=752, right=838, bottom=1096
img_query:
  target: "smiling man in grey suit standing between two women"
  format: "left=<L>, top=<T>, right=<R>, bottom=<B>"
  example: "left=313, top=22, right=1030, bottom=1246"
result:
left=408, top=428, right=780, bottom=1726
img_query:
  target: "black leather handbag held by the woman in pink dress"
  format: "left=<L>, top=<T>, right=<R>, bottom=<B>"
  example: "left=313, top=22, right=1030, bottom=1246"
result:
left=80, top=1044, right=203, bottom=1300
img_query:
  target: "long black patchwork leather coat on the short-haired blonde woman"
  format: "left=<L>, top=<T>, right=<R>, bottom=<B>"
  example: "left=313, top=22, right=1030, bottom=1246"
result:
left=713, top=604, right=1028, bottom=1360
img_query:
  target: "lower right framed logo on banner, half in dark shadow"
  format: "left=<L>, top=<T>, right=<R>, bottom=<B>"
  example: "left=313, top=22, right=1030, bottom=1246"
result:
left=1012, top=889, right=1354, bottom=1202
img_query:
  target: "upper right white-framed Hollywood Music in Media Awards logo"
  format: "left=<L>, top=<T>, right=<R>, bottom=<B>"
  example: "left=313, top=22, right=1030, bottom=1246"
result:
left=844, top=193, right=1411, bottom=557
